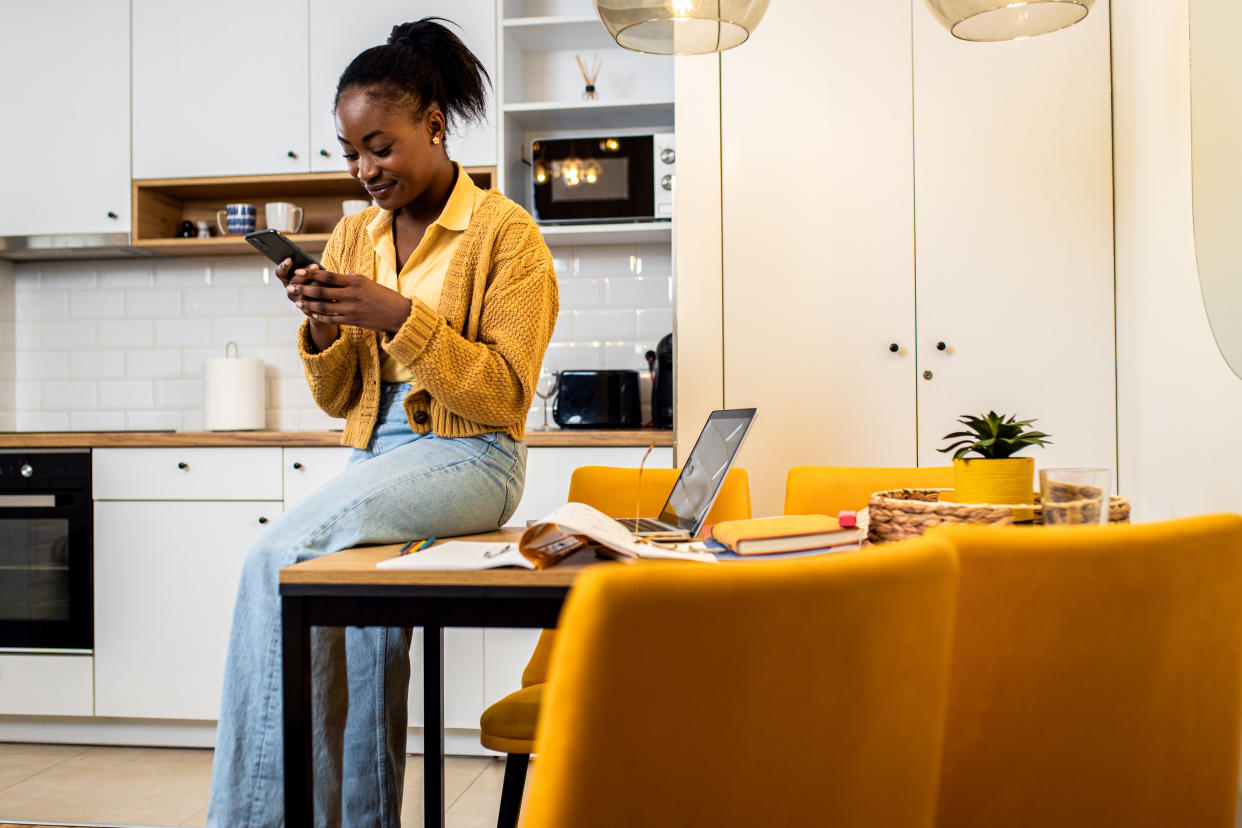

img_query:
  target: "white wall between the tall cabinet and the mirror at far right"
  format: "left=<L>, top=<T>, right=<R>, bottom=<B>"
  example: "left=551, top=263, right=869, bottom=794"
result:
left=1113, top=0, right=1242, bottom=520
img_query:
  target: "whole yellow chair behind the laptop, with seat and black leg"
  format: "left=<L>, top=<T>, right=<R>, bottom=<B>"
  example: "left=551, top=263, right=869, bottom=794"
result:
left=479, top=466, right=750, bottom=828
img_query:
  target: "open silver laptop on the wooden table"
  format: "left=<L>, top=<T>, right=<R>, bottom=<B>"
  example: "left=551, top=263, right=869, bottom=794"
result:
left=616, top=408, right=755, bottom=538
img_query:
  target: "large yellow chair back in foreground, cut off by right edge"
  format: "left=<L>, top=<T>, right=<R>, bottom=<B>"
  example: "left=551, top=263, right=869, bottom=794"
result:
left=933, top=515, right=1242, bottom=828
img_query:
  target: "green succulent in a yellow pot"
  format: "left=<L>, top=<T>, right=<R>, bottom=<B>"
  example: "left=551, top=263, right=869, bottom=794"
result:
left=936, top=411, right=1051, bottom=520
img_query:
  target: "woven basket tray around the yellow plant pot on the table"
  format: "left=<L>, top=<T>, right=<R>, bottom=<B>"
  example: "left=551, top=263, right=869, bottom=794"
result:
left=867, top=489, right=1130, bottom=544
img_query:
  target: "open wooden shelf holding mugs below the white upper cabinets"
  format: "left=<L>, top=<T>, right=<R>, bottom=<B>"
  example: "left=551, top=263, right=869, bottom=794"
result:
left=130, top=166, right=496, bottom=256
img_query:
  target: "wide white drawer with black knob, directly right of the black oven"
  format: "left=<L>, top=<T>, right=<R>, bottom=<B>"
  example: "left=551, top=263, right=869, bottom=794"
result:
left=92, top=447, right=283, bottom=500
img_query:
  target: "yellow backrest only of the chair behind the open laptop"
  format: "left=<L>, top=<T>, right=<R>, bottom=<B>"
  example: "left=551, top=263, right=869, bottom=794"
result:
left=522, top=466, right=750, bottom=688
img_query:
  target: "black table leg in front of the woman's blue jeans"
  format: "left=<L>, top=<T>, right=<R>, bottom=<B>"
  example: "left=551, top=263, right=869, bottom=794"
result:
left=281, top=596, right=314, bottom=826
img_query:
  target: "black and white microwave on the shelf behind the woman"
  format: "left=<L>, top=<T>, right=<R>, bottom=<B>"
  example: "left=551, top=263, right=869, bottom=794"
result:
left=530, top=133, right=677, bottom=225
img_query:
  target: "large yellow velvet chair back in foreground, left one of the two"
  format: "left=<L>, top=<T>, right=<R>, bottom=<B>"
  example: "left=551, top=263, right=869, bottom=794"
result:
left=522, top=539, right=956, bottom=828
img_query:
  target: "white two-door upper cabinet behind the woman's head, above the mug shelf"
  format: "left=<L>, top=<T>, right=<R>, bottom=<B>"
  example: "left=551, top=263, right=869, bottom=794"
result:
left=133, top=0, right=496, bottom=180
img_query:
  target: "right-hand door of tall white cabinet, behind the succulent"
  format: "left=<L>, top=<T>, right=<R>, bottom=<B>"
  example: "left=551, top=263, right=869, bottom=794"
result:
left=914, top=0, right=1117, bottom=468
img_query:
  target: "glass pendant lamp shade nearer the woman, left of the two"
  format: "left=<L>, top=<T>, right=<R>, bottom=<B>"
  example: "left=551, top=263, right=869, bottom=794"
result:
left=595, top=0, right=768, bottom=55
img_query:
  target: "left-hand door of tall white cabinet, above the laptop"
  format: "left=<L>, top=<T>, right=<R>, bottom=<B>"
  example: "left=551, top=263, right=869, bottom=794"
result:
left=720, top=0, right=915, bottom=515
